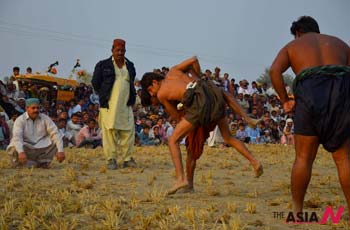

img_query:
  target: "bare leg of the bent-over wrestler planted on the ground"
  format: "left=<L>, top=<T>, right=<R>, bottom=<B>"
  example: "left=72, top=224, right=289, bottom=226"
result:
left=167, top=119, right=195, bottom=194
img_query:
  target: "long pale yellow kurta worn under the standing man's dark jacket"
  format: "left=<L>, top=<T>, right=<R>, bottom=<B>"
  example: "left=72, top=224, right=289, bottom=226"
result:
left=100, top=60, right=134, bottom=130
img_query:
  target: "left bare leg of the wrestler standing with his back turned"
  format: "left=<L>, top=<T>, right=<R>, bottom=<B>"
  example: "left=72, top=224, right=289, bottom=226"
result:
left=291, top=134, right=319, bottom=213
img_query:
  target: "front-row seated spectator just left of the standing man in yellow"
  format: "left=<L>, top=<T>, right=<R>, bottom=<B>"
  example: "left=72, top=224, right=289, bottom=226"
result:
left=77, top=118, right=102, bottom=149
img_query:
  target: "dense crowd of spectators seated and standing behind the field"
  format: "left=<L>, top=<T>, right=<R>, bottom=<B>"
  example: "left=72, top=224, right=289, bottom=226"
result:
left=0, top=67, right=294, bottom=149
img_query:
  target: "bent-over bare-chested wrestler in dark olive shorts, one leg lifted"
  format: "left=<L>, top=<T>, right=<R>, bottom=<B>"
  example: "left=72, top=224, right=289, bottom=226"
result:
left=141, top=57, right=263, bottom=194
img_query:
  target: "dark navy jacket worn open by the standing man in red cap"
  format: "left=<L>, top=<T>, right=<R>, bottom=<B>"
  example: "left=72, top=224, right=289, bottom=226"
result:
left=91, top=56, right=136, bottom=108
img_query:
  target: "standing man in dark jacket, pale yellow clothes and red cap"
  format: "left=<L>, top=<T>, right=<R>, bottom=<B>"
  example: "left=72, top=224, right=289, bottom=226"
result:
left=91, top=39, right=137, bottom=170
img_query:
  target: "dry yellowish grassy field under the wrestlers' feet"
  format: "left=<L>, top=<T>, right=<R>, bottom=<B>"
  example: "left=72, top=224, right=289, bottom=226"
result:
left=0, top=145, right=349, bottom=229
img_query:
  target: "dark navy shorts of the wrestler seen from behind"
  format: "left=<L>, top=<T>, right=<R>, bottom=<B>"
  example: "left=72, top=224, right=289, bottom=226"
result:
left=294, top=67, right=350, bottom=152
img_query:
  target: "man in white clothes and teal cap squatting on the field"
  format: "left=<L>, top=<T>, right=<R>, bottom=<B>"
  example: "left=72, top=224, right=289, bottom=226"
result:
left=7, top=98, right=65, bottom=168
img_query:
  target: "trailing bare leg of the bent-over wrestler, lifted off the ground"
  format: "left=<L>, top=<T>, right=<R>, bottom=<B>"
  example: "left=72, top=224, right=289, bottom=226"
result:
left=218, top=118, right=263, bottom=177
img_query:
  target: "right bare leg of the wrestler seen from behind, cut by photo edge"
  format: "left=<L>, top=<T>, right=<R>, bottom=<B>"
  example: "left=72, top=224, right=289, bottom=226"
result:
left=332, top=139, right=350, bottom=221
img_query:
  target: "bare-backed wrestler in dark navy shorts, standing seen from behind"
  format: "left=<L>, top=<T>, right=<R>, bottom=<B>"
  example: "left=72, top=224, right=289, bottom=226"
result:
left=270, top=16, right=350, bottom=217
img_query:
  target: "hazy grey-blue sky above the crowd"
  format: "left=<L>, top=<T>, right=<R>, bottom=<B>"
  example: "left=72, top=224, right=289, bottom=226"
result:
left=0, top=0, right=350, bottom=81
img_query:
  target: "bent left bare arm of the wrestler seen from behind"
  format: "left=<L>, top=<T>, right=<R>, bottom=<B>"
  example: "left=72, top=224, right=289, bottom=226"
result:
left=270, top=46, right=290, bottom=103
